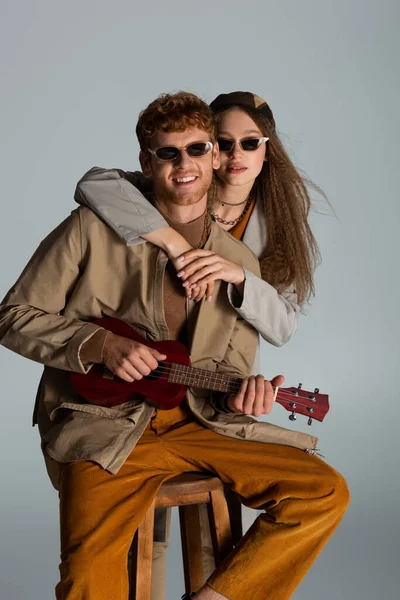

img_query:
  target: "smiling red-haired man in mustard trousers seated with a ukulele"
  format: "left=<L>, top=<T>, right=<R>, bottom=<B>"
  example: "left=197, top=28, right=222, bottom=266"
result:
left=0, top=93, right=348, bottom=600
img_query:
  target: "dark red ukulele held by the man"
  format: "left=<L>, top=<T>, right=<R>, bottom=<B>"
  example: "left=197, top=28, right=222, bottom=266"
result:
left=70, top=317, right=329, bottom=425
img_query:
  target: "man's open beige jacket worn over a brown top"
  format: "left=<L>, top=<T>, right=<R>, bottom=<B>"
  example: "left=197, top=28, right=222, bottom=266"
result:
left=0, top=207, right=317, bottom=486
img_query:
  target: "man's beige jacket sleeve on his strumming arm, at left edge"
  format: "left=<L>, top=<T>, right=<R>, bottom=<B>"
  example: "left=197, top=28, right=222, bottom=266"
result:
left=0, top=212, right=100, bottom=373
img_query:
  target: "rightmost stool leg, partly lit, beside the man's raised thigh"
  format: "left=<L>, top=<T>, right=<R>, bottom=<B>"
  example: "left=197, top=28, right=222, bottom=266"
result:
left=208, top=489, right=233, bottom=566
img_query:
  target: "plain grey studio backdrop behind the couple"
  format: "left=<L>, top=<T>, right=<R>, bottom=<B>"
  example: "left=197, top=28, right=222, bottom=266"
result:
left=0, top=0, right=400, bottom=600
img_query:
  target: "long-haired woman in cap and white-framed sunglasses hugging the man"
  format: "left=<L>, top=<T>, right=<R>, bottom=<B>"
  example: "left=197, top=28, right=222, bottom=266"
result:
left=75, top=92, right=319, bottom=600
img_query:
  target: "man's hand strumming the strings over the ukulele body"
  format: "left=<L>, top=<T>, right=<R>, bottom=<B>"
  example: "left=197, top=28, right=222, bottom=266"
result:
left=103, top=333, right=167, bottom=383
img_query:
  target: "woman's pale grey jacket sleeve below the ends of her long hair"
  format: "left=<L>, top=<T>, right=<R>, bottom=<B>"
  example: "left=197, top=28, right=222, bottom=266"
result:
left=228, top=268, right=300, bottom=346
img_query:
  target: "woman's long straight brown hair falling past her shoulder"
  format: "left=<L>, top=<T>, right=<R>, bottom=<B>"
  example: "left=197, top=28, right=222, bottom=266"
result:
left=215, top=106, right=323, bottom=304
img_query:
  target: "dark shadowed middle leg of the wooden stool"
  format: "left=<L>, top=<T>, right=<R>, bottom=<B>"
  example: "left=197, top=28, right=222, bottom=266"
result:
left=179, top=504, right=205, bottom=594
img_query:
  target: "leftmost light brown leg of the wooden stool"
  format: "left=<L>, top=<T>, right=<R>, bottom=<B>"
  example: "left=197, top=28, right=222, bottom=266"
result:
left=129, top=501, right=155, bottom=600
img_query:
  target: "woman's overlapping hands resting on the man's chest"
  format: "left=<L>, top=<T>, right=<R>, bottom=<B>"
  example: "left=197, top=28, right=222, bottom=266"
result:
left=176, top=249, right=245, bottom=301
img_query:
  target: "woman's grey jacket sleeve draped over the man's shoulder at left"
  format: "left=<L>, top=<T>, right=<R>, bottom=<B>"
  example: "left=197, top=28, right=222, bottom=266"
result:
left=75, top=167, right=168, bottom=246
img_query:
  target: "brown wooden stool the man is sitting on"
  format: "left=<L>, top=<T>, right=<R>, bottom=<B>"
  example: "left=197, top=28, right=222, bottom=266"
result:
left=129, top=473, right=242, bottom=600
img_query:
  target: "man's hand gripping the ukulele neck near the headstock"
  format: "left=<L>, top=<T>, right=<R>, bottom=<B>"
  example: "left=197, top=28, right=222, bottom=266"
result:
left=227, top=375, right=285, bottom=417
